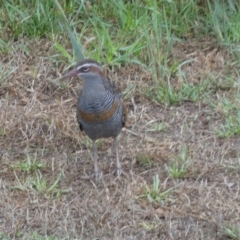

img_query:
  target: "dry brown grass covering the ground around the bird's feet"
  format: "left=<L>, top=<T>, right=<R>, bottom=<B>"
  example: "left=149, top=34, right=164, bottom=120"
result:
left=0, top=39, right=240, bottom=240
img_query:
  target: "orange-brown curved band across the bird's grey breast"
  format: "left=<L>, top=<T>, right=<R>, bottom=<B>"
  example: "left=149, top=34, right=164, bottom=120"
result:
left=78, top=100, right=119, bottom=122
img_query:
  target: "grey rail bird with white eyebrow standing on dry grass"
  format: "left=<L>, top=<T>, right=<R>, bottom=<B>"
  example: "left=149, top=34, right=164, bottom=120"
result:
left=61, top=59, right=126, bottom=179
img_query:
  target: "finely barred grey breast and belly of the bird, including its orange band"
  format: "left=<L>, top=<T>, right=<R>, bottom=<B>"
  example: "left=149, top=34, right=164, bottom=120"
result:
left=77, top=78, right=123, bottom=139
